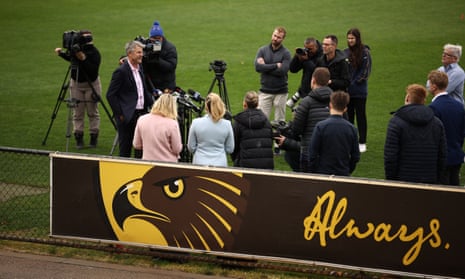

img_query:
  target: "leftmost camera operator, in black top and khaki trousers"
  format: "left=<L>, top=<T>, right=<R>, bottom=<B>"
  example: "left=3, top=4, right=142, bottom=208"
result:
left=55, top=30, right=102, bottom=149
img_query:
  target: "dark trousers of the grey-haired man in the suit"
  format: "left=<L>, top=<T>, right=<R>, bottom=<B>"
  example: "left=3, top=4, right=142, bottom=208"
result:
left=117, top=110, right=144, bottom=159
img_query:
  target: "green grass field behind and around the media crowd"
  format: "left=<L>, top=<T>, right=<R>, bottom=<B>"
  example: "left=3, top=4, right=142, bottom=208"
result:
left=0, top=0, right=465, bottom=182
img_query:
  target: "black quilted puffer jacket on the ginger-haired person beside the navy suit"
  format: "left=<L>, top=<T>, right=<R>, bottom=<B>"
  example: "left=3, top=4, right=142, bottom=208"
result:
left=384, top=104, right=447, bottom=184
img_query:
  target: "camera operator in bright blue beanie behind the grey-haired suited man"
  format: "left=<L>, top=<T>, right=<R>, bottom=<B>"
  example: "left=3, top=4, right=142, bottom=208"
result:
left=142, top=21, right=178, bottom=91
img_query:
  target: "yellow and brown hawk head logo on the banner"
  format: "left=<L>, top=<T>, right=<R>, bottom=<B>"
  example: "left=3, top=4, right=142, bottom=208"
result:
left=99, top=161, right=249, bottom=251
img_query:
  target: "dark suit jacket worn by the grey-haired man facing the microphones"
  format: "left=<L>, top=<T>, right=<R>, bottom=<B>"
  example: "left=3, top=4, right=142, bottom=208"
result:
left=107, top=61, right=153, bottom=123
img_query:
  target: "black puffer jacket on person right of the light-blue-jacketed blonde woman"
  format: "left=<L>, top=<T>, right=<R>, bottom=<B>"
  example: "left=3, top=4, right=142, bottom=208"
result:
left=231, top=109, right=274, bottom=169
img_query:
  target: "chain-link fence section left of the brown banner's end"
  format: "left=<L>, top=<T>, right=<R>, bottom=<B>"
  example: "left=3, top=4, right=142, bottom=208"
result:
left=0, top=147, right=50, bottom=239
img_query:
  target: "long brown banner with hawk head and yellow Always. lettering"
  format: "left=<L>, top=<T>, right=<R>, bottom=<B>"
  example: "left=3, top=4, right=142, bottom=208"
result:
left=51, top=154, right=465, bottom=278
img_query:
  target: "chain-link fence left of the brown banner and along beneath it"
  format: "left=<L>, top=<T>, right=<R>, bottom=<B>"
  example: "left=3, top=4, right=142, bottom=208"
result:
left=0, top=146, right=398, bottom=278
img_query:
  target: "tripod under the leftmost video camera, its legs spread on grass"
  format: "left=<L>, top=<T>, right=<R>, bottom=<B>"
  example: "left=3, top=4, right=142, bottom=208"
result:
left=42, top=63, right=116, bottom=152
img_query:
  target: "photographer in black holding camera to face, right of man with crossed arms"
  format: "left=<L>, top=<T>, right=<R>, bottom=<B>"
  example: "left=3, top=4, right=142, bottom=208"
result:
left=286, top=37, right=323, bottom=109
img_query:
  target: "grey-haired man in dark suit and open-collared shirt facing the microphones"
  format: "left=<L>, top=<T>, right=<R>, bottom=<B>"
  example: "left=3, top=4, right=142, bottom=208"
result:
left=107, top=41, right=153, bottom=158
